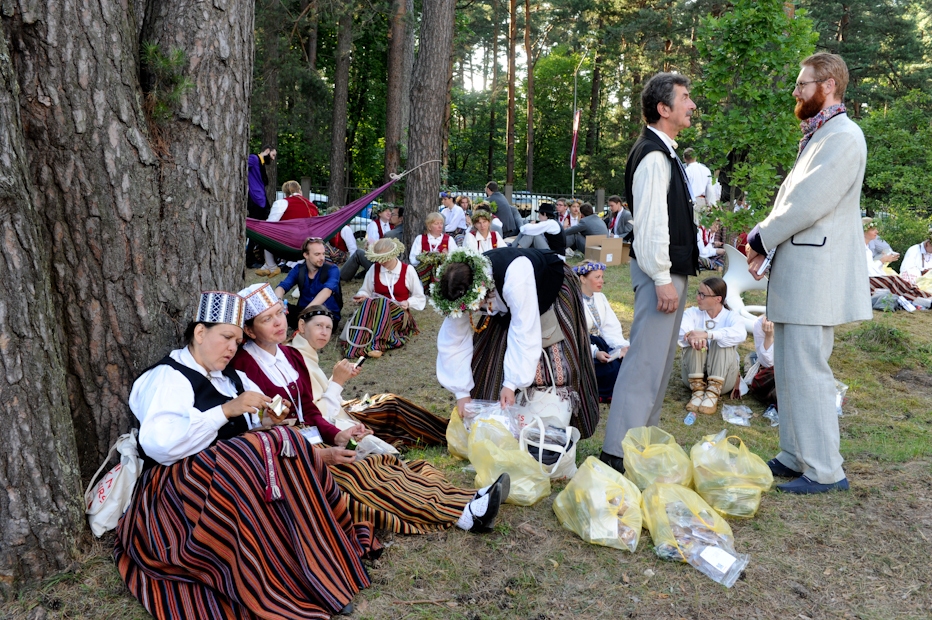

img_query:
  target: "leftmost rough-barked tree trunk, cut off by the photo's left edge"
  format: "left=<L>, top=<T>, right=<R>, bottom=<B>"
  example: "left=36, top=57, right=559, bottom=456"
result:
left=0, top=26, right=84, bottom=600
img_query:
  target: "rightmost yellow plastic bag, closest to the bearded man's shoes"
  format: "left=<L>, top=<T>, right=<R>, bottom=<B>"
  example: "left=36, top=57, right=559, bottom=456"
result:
left=689, top=431, right=773, bottom=517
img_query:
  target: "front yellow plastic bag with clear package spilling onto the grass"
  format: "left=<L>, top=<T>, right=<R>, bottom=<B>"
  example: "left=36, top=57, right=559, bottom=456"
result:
left=641, top=482, right=750, bottom=588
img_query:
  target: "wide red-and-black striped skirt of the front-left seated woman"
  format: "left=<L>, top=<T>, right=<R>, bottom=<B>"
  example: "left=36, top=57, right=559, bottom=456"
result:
left=114, top=429, right=378, bottom=620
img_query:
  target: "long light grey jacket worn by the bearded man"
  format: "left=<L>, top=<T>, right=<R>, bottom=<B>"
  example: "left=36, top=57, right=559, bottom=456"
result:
left=759, top=114, right=872, bottom=326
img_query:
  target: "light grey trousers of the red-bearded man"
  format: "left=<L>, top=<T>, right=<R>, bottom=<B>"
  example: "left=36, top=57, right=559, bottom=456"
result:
left=773, top=323, right=845, bottom=484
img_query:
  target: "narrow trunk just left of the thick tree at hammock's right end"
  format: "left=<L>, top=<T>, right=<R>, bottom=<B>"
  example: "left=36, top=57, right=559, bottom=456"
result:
left=383, top=0, right=408, bottom=202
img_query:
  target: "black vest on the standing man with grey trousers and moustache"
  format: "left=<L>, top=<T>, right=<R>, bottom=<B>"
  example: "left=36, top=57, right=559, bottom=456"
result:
left=625, top=127, right=699, bottom=276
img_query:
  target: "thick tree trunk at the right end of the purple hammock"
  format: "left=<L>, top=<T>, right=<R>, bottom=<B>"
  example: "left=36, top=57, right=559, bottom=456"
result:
left=404, top=0, right=456, bottom=252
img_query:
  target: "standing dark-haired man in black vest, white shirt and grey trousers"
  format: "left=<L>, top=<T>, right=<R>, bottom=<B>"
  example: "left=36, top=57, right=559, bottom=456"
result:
left=601, top=73, right=699, bottom=471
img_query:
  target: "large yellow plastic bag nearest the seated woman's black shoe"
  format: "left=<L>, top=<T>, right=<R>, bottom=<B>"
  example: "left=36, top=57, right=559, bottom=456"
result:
left=469, top=418, right=550, bottom=506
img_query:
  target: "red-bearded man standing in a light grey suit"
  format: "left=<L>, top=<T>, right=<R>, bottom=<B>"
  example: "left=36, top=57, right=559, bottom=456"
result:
left=748, top=53, right=872, bottom=494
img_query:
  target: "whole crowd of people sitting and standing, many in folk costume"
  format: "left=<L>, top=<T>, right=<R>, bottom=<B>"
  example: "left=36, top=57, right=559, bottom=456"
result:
left=109, top=54, right=932, bottom=618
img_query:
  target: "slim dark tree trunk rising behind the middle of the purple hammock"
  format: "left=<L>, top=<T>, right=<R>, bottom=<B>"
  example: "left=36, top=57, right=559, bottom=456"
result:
left=327, top=0, right=353, bottom=207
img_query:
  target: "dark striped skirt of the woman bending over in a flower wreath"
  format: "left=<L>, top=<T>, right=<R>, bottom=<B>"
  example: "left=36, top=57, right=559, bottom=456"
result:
left=472, top=265, right=599, bottom=439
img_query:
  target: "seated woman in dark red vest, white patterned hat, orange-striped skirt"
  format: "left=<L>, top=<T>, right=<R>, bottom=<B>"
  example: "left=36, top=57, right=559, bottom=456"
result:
left=232, top=284, right=508, bottom=534
